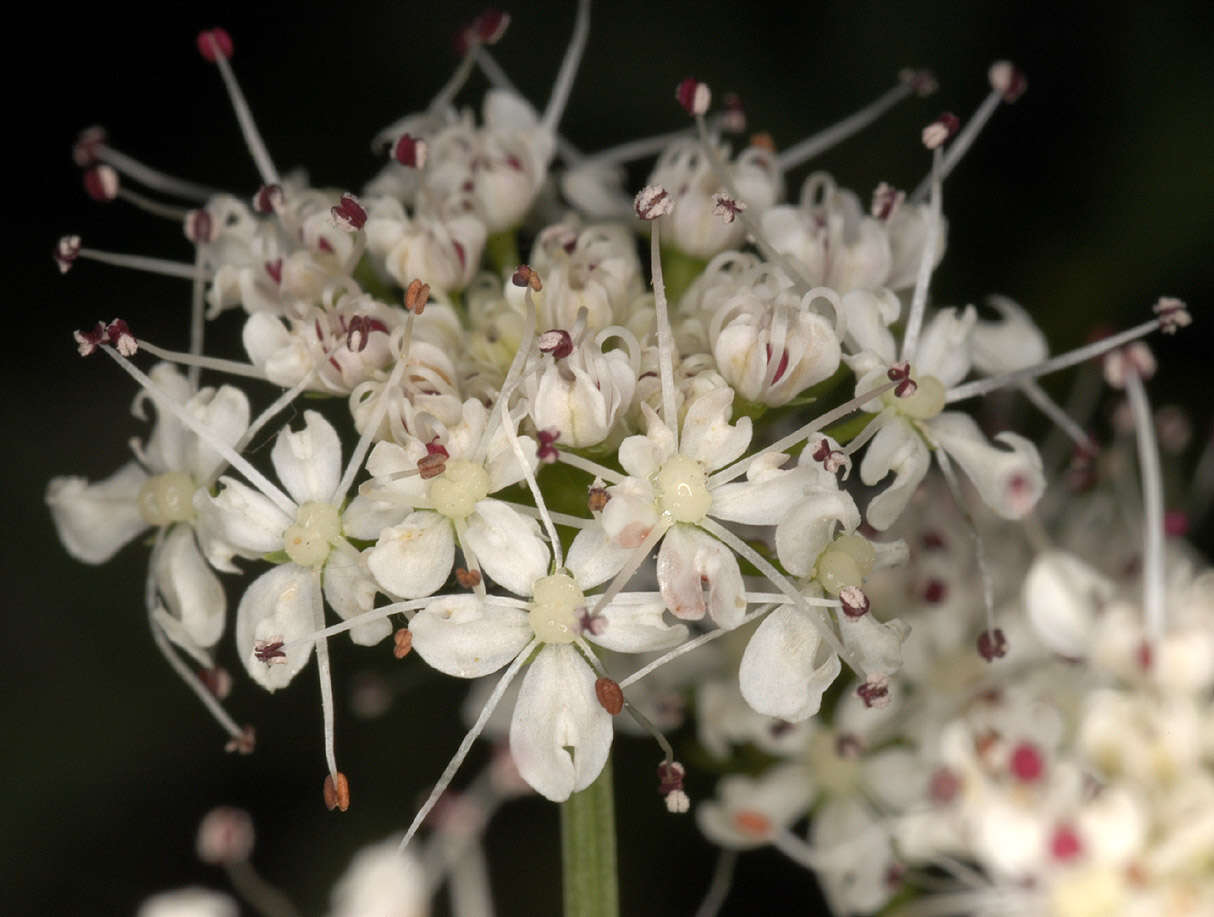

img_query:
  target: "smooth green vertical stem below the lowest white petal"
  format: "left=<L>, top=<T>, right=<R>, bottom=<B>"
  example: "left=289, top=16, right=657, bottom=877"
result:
left=561, top=758, right=619, bottom=917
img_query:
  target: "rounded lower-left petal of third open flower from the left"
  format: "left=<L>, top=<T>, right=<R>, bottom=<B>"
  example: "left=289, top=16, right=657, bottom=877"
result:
left=367, top=510, right=455, bottom=599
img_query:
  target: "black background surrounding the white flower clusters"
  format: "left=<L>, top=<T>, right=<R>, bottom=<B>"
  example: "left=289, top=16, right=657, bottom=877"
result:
left=0, top=0, right=1214, bottom=916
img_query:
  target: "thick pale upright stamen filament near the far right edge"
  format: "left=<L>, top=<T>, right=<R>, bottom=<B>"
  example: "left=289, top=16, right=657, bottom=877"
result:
left=1125, top=369, right=1167, bottom=645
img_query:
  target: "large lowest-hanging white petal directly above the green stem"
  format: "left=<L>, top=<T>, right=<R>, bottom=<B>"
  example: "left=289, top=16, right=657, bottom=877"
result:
left=510, top=646, right=612, bottom=803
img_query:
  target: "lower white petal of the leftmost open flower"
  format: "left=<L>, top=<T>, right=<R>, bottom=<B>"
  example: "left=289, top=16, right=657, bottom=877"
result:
left=153, top=526, right=227, bottom=646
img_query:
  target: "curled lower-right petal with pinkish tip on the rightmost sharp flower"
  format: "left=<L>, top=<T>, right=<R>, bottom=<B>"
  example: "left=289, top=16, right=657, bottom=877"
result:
left=927, top=411, right=1045, bottom=519
